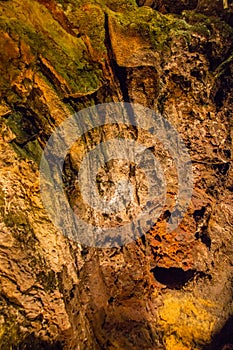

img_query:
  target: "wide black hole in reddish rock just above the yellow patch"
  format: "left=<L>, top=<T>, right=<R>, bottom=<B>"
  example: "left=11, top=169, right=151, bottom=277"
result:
left=151, top=266, right=196, bottom=289
